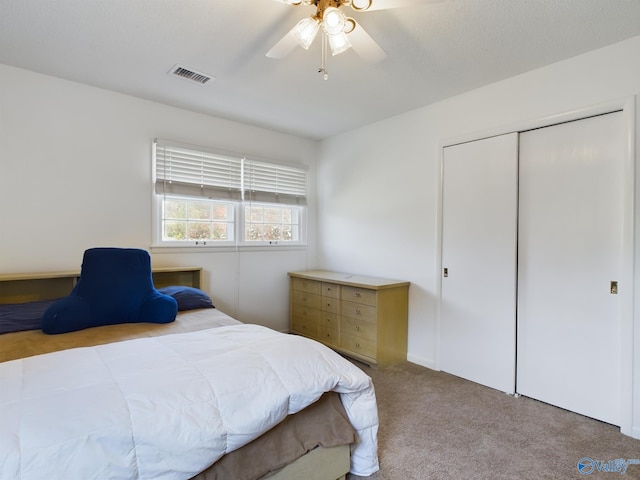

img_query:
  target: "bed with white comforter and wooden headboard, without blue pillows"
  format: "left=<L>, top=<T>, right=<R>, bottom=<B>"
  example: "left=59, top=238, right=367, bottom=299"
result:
left=0, top=267, right=378, bottom=480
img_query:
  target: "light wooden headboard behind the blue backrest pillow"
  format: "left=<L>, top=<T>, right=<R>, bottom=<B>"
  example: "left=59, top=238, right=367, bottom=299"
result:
left=0, top=267, right=202, bottom=304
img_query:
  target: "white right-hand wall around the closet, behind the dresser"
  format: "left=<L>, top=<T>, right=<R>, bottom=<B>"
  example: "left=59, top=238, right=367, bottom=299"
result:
left=318, top=37, right=640, bottom=436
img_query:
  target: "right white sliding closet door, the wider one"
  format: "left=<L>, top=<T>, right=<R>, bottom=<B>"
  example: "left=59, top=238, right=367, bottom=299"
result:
left=517, top=112, right=626, bottom=425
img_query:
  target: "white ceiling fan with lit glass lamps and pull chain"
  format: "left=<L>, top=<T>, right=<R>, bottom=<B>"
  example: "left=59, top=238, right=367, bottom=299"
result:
left=267, top=0, right=443, bottom=80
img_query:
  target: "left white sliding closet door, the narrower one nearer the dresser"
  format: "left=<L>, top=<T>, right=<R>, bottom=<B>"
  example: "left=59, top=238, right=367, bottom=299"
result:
left=440, top=133, right=518, bottom=393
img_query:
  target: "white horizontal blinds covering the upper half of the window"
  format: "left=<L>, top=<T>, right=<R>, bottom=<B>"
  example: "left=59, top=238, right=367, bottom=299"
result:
left=154, top=139, right=307, bottom=205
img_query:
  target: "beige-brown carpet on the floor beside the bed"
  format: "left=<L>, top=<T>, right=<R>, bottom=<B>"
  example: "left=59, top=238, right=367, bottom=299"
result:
left=347, top=362, right=640, bottom=480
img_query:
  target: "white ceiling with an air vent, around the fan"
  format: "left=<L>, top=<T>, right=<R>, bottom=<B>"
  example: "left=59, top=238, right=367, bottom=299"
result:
left=0, top=0, right=640, bottom=139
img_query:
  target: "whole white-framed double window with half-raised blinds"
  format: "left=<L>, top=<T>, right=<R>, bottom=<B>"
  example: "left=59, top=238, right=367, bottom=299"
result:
left=153, top=140, right=307, bottom=245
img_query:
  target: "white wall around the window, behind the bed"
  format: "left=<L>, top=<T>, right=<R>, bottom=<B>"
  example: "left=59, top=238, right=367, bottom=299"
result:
left=0, top=65, right=317, bottom=330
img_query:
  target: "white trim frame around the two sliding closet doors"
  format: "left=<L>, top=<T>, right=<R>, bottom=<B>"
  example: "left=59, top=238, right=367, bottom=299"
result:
left=434, top=96, right=640, bottom=438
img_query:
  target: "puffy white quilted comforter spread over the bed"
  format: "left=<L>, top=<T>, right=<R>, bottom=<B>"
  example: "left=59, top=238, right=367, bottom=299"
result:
left=0, top=325, right=378, bottom=480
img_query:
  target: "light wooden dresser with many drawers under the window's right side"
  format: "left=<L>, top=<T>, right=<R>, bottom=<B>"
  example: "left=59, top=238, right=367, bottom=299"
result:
left=289, top=270, right=409, bottom=366
